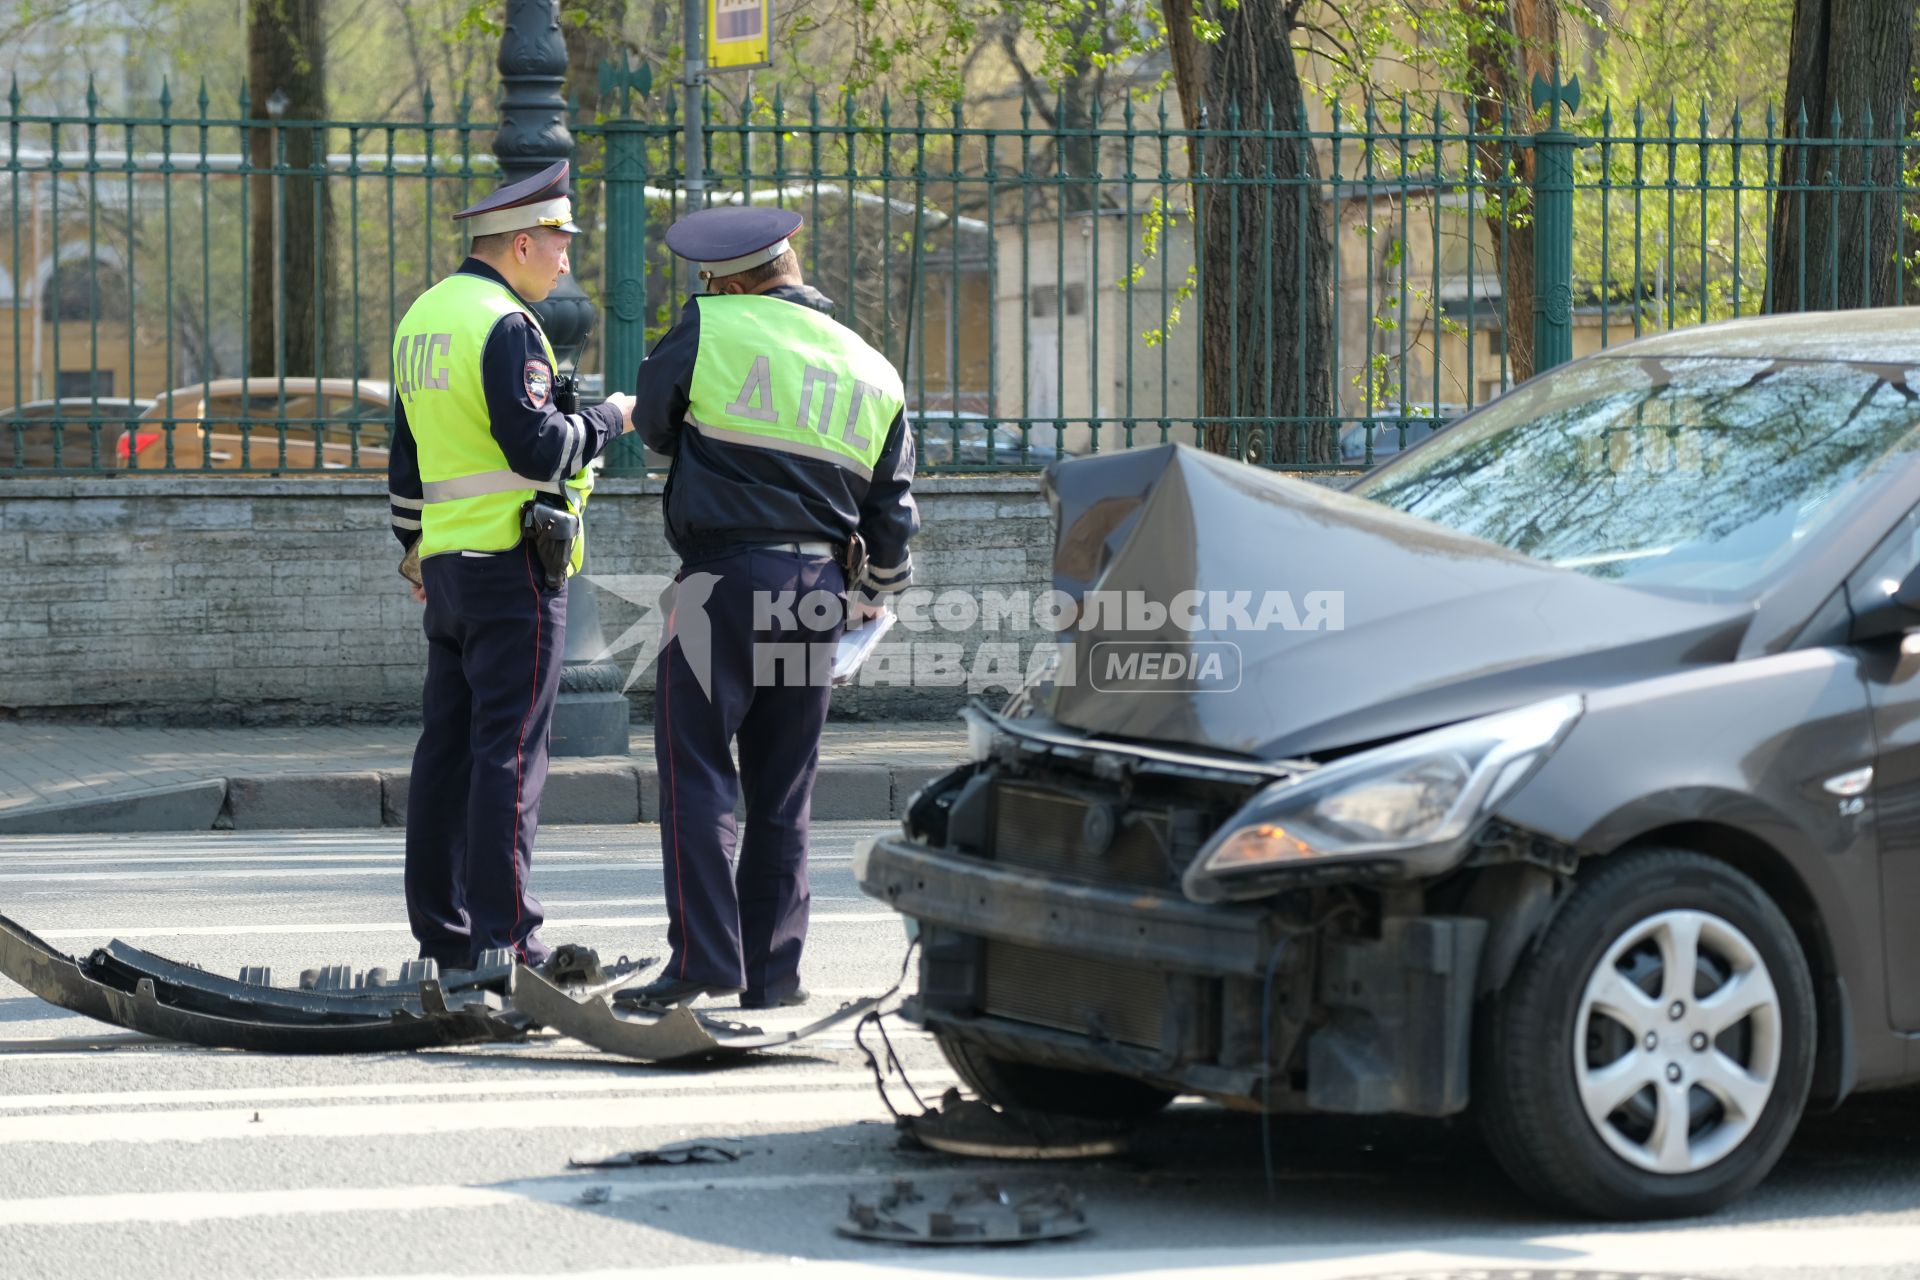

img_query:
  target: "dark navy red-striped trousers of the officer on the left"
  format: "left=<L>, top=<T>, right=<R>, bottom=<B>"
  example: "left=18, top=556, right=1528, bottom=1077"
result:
left=407, top=545, right=566, bottom=967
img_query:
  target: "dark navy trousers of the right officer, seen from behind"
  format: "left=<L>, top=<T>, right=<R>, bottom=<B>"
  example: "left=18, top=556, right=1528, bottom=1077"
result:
left=655, top=551, right=845, bottom=1002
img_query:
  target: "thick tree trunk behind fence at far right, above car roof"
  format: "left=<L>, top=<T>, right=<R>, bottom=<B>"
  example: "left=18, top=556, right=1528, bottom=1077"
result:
left=1766, top=0, right=1916, bottom=311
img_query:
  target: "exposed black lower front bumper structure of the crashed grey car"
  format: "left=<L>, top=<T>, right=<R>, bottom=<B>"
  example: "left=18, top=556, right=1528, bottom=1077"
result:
left=854, top=839, right=1486, bottom=1115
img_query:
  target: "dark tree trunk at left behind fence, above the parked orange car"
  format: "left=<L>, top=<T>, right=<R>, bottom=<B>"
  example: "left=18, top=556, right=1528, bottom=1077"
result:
left=246, top=0, right=332, bottom=376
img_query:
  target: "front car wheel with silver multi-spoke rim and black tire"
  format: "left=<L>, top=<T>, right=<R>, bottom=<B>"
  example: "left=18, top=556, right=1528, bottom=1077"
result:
left=1473, top=848, right=1816, bottom=1219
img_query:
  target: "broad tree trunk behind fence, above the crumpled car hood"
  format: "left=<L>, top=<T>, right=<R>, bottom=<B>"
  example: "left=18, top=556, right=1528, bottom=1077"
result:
left=1164, top=0, right=1338, bottom=462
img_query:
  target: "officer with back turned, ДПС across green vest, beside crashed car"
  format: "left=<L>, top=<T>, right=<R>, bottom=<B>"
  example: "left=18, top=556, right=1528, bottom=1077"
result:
left=622, top=207, right=920, bottom=1009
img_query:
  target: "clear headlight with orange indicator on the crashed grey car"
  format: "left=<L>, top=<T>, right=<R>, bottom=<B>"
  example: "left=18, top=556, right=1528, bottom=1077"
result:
left=1183, top=695, right=1584, bottom=902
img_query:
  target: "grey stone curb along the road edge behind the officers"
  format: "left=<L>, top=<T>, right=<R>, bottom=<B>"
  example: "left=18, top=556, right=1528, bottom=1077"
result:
left=0, top=758, right=952, bottom=835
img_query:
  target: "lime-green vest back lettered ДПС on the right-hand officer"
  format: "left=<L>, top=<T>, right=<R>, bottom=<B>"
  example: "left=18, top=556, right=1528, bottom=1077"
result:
left=687, top=294, right=906, bottom=480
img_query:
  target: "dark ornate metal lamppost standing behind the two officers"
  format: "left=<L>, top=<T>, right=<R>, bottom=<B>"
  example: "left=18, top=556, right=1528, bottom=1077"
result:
left=493, top=0, right=628, bottom=756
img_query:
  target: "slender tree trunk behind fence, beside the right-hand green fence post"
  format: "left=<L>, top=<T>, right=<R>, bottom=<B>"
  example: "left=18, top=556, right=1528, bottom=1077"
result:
left=1459, top=0, right=1559, bottom=382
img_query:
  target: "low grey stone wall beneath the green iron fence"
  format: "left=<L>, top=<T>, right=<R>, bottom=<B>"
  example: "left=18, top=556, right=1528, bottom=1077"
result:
left=0, top=474, right=1052, bottom=723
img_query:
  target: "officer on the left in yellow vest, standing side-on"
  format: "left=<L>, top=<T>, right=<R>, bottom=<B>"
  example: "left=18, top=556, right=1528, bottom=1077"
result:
left=388, top=161, right=634, bottom=969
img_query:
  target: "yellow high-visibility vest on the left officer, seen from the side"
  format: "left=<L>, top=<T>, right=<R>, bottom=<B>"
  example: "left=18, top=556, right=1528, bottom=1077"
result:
left=394, top=274, right=593, bottom=572
